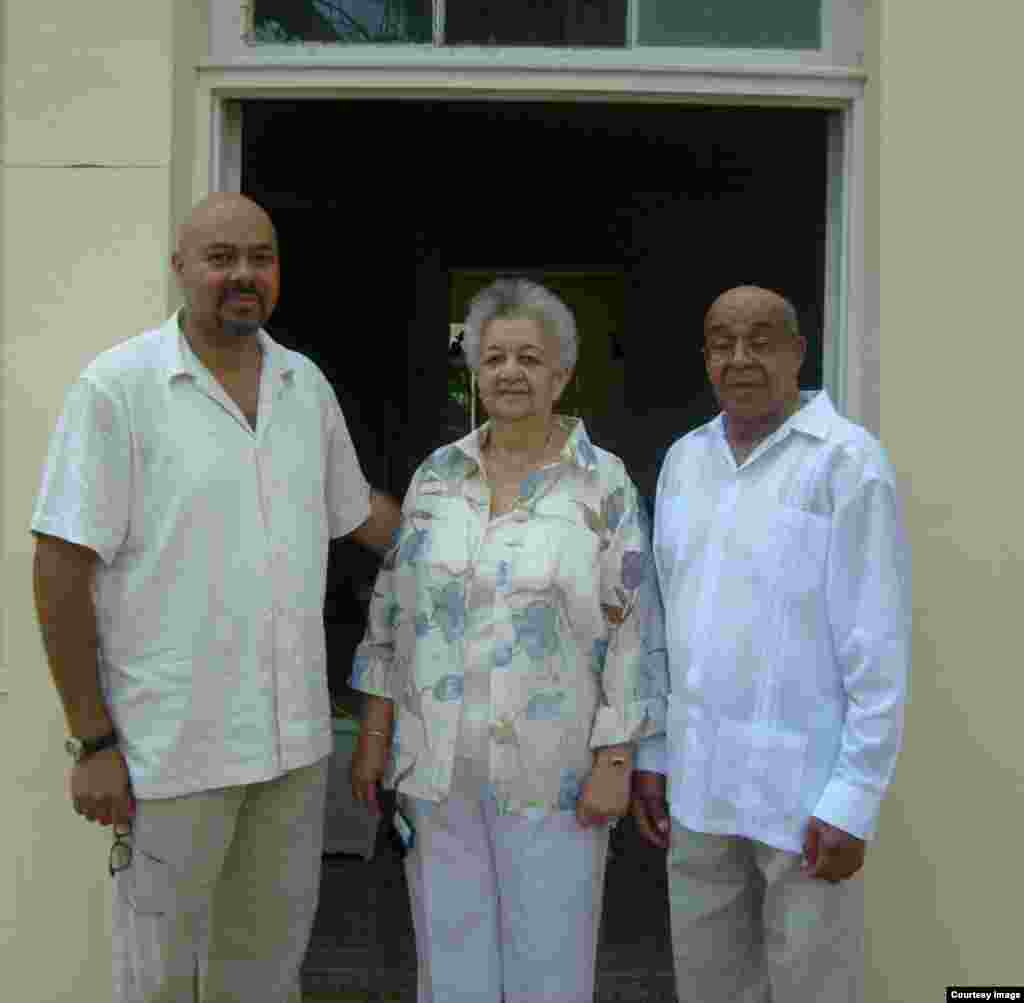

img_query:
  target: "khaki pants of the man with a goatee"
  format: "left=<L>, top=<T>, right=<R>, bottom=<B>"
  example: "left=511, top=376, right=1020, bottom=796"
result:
left=114, top=759, right=327, bottom=1003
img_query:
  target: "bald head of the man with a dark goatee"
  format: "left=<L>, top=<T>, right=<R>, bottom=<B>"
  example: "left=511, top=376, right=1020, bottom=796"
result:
left=171, top=192, right=281, bottom=343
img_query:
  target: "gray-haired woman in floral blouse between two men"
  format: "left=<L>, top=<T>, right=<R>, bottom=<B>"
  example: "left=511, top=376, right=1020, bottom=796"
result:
left=351, top=280, right=668, bottom=1003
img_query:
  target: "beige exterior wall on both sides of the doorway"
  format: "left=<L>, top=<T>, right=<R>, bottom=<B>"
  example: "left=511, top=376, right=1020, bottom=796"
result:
left=0, top=0, right=1024, bottom=1003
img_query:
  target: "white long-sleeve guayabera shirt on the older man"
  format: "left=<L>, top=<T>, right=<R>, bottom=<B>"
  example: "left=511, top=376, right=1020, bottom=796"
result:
left=637, top=391, right=910, bottom=852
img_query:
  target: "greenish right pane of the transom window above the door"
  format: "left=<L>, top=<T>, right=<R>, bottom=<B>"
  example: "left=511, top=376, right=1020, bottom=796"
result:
left=636, top=0, right=821, bottom=49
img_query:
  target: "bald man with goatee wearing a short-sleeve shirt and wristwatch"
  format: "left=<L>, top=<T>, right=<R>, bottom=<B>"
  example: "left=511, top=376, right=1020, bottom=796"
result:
left=32, top=194, right=398, bottom=1003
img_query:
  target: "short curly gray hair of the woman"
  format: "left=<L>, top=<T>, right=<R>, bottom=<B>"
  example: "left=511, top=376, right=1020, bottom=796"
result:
left=462, top=279, right=577, bottom=373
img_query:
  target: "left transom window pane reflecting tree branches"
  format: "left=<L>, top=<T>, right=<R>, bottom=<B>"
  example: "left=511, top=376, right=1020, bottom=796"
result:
left=253, top=0, right=433, bottom=44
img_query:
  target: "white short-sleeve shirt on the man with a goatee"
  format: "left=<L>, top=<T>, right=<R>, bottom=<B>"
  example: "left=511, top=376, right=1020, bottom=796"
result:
left=32, top=315, right=370, bottom=797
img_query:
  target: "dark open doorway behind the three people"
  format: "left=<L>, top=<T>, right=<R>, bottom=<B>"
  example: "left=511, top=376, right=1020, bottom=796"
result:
left=242, top=100, right=828, bottom=1000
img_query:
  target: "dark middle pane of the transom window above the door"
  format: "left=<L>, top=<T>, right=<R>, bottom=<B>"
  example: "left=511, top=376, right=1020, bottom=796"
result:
left=444, top=0, right=627, bottom=47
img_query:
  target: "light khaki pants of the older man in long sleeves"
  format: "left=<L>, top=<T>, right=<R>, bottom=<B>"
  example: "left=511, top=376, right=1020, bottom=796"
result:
left=669, top=820, right=864, bottom=1003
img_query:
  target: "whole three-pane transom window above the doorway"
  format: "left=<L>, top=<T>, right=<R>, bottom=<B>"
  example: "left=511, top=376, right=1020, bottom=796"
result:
left=253, top=0, right=823, bottom=50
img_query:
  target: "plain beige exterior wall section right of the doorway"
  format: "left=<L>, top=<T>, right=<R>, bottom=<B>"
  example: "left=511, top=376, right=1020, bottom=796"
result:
left=867, top=0, right=1024, bottom=1003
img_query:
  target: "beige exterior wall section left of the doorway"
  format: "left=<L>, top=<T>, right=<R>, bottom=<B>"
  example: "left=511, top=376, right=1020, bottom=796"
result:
left=0, top=0, right=205, bottom=1003
